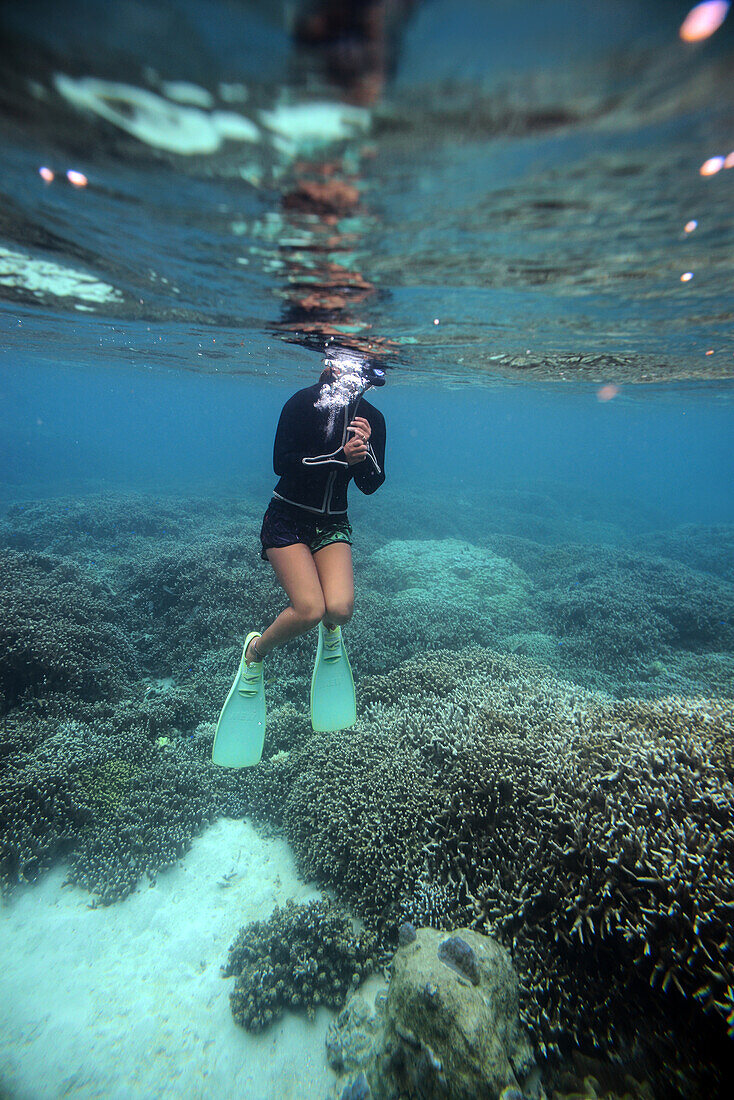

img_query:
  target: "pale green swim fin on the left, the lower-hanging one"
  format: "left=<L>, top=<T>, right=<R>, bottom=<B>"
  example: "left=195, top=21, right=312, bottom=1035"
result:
left=211, top=630, right=265, bottom=768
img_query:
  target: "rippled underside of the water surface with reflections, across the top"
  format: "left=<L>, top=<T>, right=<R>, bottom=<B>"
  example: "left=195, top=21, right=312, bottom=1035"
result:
left=0, top=0, right=734, bottom=381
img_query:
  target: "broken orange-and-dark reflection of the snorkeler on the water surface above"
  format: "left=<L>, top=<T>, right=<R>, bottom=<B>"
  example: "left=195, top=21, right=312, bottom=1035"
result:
left=268, top=0, right=415, bottom=387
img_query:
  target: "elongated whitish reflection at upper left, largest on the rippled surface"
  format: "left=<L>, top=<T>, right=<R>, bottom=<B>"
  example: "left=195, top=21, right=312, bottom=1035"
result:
left=54, top=73, right=260, bottom=156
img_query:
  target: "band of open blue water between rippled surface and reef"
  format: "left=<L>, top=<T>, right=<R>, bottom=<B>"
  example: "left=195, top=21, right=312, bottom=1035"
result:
left=0, top=366, right=734, bottom=530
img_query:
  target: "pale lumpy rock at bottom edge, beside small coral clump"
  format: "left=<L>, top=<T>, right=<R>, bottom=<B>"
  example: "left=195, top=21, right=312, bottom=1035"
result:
left=327, top=928, right=533, bottom=1100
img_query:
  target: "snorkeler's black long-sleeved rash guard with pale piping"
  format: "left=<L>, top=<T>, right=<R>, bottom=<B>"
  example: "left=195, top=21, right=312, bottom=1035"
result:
left=273, top=383, right=385, bottom=516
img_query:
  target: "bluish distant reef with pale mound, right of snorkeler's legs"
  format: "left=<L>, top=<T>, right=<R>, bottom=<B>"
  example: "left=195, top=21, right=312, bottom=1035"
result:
left=350, top=512, right=734, bottom=697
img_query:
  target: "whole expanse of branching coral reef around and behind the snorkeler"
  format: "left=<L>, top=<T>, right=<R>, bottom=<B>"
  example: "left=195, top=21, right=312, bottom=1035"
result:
left=0, top=495, right=734, bottom=1098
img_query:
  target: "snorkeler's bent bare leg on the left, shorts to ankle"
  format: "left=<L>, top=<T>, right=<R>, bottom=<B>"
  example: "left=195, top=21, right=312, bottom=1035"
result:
left=245, top=542, right=328, bottom=662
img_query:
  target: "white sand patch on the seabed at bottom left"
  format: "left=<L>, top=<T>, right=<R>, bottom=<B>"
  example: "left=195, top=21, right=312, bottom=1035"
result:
left=0, top=820, right=333, bottom=1100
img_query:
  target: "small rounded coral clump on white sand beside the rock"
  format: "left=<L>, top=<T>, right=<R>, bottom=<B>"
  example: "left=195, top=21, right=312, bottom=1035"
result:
left=222, top=901, right=375, bottom=1032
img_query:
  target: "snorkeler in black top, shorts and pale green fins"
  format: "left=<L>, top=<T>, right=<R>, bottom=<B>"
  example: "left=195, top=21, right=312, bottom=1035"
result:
left=212, top=350, right=385, bottom=768
